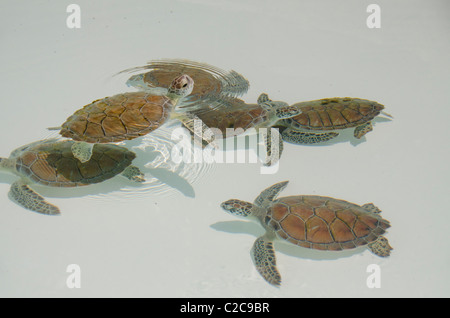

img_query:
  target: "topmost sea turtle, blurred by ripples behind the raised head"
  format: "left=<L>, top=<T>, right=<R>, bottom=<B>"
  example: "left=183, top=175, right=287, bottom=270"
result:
left=120, top=59, right=249, bottom=110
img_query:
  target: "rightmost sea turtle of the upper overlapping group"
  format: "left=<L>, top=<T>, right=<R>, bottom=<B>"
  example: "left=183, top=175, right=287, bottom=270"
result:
left=279, top=97, right=392, bottom=144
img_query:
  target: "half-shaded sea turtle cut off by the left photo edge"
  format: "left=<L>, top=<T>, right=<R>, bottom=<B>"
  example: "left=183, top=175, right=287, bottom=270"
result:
left=0, top=139, right=144, bottom=214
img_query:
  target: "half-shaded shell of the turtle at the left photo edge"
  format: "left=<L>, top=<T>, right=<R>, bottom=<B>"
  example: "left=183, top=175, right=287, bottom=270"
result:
left=16, top=140, right=136, bottom=187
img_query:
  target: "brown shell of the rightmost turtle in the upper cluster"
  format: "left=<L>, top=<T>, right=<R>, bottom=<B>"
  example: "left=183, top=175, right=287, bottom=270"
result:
left=285, top=97, right=384, bottom=130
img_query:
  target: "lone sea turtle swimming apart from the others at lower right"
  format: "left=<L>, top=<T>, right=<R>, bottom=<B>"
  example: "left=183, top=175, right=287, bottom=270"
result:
left=221, top=181, right=392, bottom=286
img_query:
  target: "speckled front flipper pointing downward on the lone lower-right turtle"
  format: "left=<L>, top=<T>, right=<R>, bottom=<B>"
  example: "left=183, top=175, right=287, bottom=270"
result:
left=251, top=235, right=281, bottom=286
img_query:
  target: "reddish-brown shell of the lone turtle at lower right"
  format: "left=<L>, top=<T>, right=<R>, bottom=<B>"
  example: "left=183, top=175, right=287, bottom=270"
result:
left=265, top=196, right=390, bottom=251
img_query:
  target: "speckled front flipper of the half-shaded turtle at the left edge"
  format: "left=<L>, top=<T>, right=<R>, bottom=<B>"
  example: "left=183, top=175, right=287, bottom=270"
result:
left=8, top=180, right=60, bottom=215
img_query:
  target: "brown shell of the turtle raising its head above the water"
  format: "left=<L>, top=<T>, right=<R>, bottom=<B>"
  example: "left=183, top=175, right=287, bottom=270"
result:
left=60, top=91, right=174, bottom=143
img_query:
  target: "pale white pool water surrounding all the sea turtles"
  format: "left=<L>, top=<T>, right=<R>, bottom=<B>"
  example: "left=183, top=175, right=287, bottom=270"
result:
left=0, top=0, right=450, bottom=297
